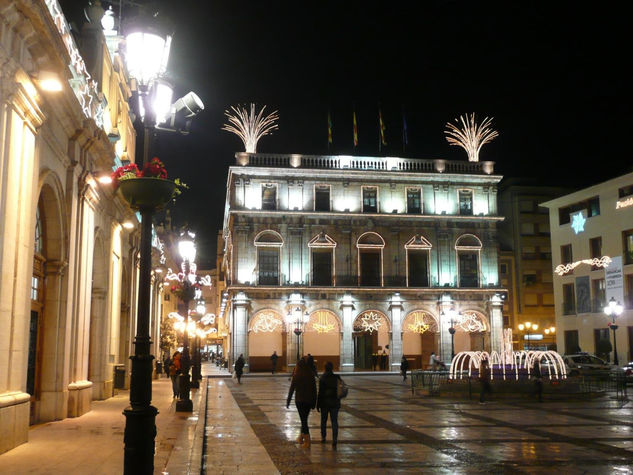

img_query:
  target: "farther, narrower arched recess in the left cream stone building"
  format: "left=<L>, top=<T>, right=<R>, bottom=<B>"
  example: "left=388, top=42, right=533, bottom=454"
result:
left=88, top=229, right=112, bottom=399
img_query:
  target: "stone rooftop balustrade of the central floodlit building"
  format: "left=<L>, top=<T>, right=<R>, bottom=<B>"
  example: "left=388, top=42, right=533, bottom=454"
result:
left=235, top=152, right=494, bottom=175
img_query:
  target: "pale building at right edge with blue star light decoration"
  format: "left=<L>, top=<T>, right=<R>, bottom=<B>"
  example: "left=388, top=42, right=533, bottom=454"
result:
left=541, top=173, right=633, bottom=364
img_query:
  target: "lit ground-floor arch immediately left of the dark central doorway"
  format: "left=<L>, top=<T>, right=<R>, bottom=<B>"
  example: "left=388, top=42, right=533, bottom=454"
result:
left=302, top=309, right=342, bottom=371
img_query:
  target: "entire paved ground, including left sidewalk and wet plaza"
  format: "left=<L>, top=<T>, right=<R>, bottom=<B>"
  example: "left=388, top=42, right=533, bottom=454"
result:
left=0, top=365, right=633, bottom=475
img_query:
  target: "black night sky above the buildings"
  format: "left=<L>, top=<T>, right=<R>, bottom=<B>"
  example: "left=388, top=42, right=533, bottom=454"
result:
left=61, top=0, right=633, bottom=266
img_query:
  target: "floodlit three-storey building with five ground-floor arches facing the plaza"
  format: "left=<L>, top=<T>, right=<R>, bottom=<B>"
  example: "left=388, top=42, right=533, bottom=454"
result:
left=220, top=153, right=503, bottom=371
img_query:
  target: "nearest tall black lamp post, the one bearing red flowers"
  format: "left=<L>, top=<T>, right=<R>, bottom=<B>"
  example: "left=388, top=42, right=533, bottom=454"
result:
left=123, top=13, right=171, bottom=474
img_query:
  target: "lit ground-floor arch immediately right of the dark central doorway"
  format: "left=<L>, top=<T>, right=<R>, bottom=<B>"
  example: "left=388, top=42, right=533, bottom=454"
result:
left=402, top=310, right=439, bottom=370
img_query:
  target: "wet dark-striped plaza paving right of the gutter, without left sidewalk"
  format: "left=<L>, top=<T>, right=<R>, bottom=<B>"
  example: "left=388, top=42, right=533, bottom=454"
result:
left=216, top=374, right=633, bottom=474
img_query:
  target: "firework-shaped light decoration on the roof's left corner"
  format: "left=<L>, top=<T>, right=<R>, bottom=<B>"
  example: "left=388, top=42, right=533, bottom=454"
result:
left=222, top=103, right=279, bottom=153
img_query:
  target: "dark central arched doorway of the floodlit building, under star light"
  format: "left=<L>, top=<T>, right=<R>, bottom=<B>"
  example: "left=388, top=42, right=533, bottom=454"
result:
left=352, top=310, right=391, bottom=370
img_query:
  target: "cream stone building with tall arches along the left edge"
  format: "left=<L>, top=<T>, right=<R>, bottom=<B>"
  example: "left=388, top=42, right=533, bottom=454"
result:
left=0, top=0, right=162, bottom=452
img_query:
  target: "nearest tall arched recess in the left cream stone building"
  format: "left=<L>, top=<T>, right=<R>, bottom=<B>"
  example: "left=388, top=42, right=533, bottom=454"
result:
left=27, top=177, right=70, bottom=424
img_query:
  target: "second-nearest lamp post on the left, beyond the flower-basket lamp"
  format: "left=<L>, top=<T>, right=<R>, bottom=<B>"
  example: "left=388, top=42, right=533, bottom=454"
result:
left=176, top=231, right=196, bottom=412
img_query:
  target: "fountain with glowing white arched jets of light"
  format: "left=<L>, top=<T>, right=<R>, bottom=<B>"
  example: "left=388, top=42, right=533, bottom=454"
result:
left=449, top=328, right=567, bottom=380
